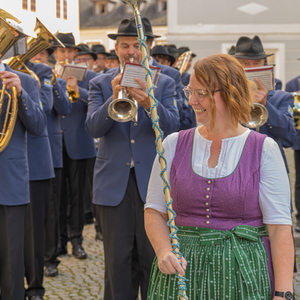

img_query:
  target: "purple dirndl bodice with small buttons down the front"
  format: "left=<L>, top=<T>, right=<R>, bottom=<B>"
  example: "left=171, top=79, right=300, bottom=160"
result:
left=170, top=129, right=266, bottom=230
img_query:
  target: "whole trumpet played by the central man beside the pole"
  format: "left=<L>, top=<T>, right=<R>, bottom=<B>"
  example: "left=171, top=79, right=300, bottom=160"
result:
left=108, top=58, right=138, bottom=126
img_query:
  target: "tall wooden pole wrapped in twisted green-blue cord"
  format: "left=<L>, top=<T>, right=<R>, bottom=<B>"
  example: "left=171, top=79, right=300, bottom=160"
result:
left=122, top=0, right=188, bottom=300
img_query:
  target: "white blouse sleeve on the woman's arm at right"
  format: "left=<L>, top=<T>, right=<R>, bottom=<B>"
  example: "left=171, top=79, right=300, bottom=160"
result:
left=259, top=137, right=292, bottom=225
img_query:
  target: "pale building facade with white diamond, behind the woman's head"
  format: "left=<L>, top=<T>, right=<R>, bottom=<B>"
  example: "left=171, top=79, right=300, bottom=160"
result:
left=166, top=0, right=300, bottom=87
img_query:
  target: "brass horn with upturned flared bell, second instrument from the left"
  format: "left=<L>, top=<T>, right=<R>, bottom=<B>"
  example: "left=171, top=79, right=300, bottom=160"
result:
left=7, top=18, right=64, bottom=87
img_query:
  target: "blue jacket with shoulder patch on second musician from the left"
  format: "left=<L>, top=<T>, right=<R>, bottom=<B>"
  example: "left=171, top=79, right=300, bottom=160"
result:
left=26, top=61, right=55, bottom=181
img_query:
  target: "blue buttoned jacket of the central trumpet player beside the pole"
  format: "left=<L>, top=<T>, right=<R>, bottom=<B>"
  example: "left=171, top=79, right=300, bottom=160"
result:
left=86, top=68, right=179, bottom=206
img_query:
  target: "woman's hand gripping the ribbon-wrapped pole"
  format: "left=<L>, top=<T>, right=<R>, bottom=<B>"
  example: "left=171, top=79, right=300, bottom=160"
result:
left=157, top=249, right=187, bottom=275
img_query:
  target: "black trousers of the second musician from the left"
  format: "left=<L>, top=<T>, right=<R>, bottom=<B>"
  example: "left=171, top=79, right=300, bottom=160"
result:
left=24, top=179, right=50, bottom=297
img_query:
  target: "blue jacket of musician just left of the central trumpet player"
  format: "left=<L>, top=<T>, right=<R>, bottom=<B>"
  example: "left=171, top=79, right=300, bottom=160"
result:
left=61, top=70, right=96, bottom=160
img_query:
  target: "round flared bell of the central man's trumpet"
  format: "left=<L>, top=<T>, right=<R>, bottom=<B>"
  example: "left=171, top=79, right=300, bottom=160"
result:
left=108, top=98, right=137, bottom=122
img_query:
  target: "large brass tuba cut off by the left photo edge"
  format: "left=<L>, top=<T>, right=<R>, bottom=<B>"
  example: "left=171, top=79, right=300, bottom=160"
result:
left=0, top=10, right=27, bottom=152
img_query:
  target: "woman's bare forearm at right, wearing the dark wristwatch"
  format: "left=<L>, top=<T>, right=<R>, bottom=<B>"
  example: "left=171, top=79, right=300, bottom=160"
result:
left=267, top=225, right=294, bottom=300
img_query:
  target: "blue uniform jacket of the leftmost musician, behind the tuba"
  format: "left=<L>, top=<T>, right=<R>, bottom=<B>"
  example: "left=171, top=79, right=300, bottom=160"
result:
left=0, top=65, right=46, bottom=206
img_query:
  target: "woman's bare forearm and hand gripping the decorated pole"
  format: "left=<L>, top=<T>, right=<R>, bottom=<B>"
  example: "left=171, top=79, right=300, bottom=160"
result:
left=145, top=208, right=187, bottom=275
